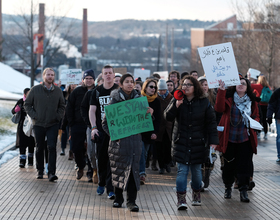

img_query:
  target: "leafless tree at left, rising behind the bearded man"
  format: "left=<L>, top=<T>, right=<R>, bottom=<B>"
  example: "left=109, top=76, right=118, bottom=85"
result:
left=4, top=0, right=74, bottom=87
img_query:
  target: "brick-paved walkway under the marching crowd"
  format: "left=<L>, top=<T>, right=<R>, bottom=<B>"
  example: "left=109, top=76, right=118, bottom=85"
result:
left=0, top=134, right=280, bottom=220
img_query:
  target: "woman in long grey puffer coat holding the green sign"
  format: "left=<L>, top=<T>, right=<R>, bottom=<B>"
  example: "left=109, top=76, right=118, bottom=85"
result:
left=102, top=73, right=148, bottom=212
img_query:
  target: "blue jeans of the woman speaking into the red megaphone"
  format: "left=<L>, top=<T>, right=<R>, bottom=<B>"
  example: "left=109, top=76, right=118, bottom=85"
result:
left=176, top=163, right=202, bottom=192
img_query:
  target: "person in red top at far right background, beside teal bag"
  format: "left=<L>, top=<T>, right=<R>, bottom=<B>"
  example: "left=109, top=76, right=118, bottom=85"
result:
left=252, top=75, right=270, bottom=140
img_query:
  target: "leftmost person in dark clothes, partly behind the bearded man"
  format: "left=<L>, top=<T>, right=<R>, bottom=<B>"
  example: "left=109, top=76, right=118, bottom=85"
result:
left=12, top=88, right=35, bottom=168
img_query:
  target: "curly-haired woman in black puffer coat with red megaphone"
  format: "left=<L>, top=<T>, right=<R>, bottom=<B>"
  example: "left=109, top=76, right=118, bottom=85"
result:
left=164, top=76, right=219, bottom=210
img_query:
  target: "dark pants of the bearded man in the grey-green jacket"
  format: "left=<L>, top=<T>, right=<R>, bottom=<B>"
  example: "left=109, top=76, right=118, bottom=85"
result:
left=33, top=124, right=58, bottom=174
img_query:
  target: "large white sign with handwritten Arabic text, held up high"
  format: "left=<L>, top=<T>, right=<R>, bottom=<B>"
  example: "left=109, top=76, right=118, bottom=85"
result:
left=197, top=42, right=240, bottom=88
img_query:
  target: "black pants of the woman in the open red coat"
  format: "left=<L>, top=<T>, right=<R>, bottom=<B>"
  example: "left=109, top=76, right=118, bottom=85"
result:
left=222, top=141, right=253, bottom=190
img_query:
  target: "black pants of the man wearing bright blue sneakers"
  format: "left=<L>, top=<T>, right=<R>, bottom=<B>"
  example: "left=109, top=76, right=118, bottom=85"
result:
left=96, top=133, right=114, bottom=194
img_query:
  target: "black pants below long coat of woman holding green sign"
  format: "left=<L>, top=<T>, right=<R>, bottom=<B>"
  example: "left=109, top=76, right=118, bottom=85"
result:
left=115, top=171, right=137, bottom=204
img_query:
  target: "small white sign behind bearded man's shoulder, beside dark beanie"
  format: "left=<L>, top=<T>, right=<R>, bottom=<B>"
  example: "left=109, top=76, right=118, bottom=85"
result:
left=60, top=69, right=82, bottom=85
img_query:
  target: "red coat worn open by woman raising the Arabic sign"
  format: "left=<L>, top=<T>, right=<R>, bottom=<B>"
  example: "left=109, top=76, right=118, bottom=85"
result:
left=215, top=89, right=260, bottom=154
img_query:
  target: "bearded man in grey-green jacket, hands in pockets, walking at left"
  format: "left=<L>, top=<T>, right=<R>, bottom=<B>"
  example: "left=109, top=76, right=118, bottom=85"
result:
left=24, top=68, right=65, bottom=182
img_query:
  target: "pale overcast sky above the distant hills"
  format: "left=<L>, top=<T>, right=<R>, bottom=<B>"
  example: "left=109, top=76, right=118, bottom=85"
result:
left=2, top=0, right=234, bottom=21
